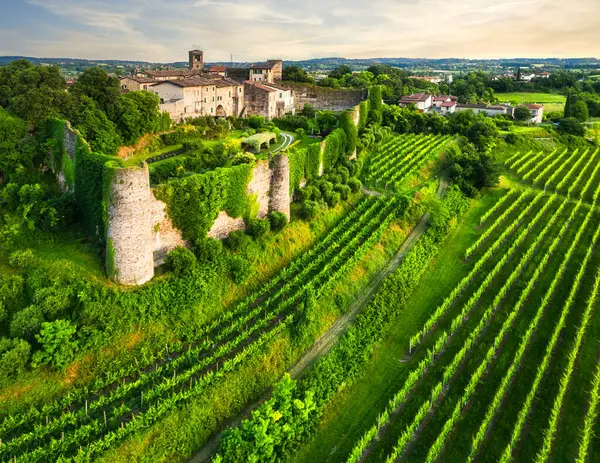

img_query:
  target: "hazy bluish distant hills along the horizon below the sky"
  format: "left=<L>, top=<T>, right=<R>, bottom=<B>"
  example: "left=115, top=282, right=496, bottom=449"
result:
left=0, top=56, right=600, bottom=72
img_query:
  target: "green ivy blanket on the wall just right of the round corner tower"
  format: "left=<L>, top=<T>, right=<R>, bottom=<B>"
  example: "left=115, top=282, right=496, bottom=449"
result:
left=155, top=164, right=252, bottom=240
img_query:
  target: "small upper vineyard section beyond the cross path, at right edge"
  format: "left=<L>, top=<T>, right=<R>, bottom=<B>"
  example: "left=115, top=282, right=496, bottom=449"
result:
left=505, top=149, right=600, bottom=202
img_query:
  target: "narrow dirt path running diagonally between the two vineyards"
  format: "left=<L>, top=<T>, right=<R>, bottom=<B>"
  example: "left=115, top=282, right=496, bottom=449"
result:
left=189, top=172, right=448, bottom=463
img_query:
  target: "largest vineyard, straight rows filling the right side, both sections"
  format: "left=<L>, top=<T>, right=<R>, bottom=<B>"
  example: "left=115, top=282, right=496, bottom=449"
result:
left=331, top=150, right=600, bottom=463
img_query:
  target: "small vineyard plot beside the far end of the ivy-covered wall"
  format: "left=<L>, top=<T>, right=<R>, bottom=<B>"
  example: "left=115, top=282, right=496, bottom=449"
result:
left=365, top=135, right=451, bottom=189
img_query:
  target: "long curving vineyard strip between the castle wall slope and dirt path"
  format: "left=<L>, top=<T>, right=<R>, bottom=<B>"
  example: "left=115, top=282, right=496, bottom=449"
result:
left=0, top=194, right=399, bottom=462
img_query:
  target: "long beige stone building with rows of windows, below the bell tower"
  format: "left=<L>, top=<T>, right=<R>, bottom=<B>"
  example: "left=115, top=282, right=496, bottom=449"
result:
left=148, top=76, right=244, bottom=121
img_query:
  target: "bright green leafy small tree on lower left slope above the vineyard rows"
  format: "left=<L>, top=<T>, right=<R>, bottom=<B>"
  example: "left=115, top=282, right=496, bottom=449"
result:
left=32, top=320, right=78, bottom=369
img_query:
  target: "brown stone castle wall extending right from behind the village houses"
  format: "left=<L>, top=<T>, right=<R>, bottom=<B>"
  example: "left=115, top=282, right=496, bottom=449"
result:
left=281, top=82, right=367, bottom=111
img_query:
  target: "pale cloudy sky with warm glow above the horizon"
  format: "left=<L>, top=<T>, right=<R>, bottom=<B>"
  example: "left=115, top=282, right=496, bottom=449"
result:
left=0, top=0, right=600, bottom=62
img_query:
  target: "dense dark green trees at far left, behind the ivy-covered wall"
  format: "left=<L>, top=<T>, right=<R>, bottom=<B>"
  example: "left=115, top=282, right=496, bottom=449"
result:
left=0, top=60, right=170, bottom=154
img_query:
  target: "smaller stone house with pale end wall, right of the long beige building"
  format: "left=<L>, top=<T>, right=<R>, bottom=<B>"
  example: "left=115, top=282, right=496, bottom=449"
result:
left=244, top=81, right=296, bottom=119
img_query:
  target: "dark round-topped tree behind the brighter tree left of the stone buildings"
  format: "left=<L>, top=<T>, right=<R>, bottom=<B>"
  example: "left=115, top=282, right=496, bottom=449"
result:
left=71, top=67, right=120, bottom=121
